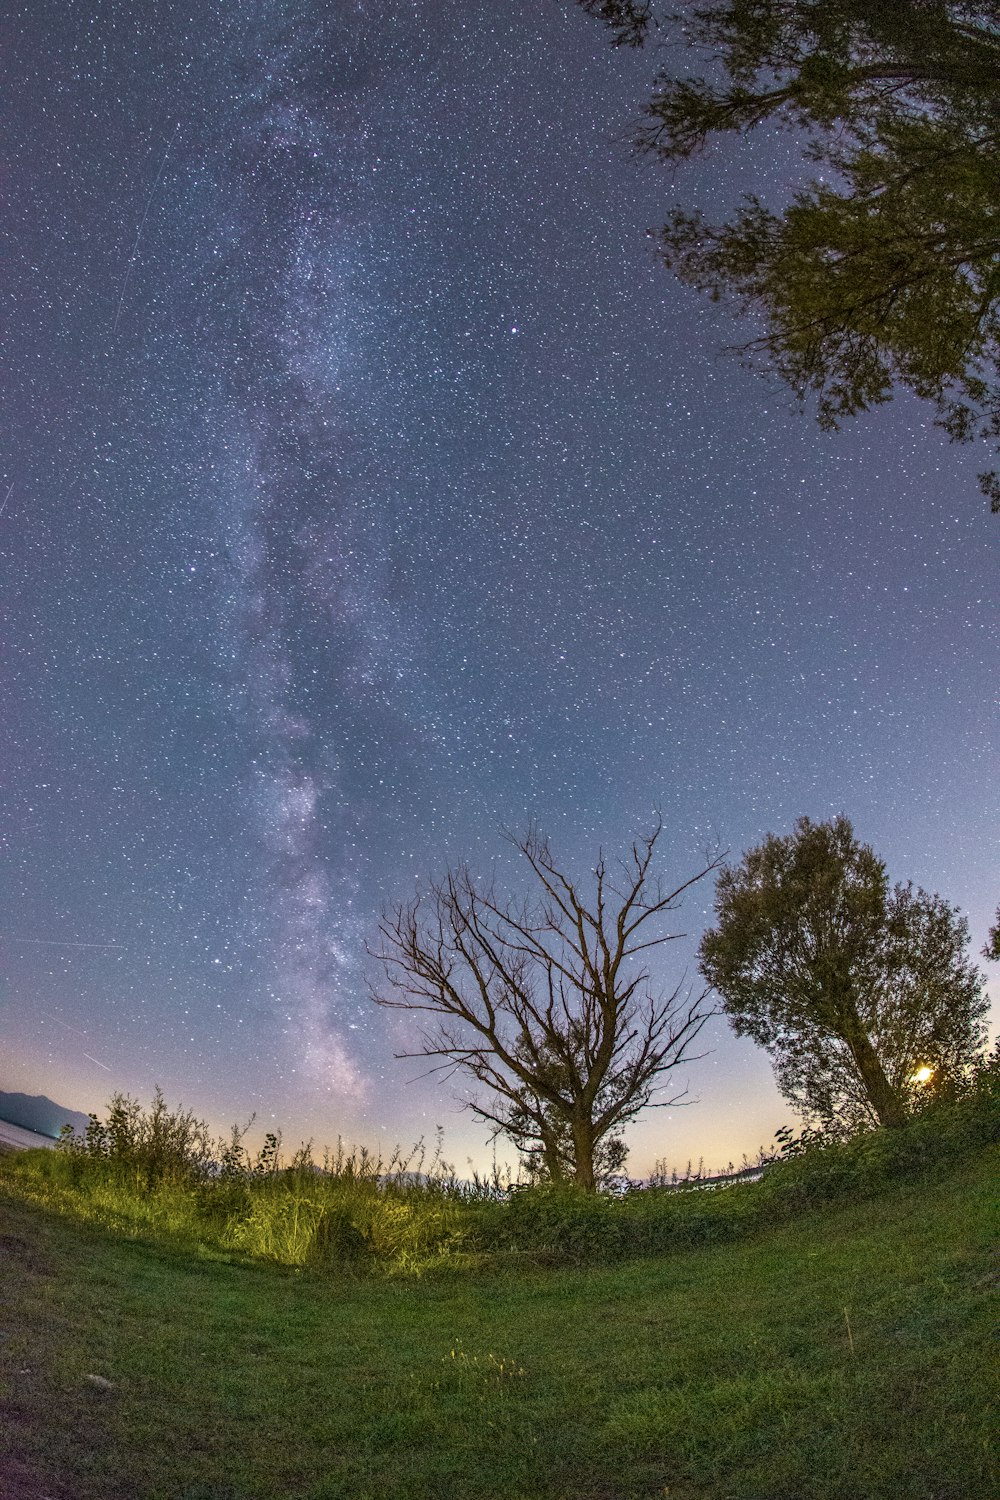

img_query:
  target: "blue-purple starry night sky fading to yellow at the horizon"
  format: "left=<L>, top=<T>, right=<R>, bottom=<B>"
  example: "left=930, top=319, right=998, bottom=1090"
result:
left=0, top=0, right=1000, bottom=1173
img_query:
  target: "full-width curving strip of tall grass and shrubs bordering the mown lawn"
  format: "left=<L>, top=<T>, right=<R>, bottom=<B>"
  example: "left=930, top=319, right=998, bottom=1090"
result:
left=1, top=1067, right=1000, bottom=1275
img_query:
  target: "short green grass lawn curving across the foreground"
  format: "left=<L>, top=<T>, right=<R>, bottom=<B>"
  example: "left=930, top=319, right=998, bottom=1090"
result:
left=0, top=1149, right=997, bottom=1500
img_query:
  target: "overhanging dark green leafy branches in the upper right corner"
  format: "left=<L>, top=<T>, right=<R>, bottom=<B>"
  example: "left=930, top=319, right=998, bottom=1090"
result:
left=579, top=0, right=1000, bottom=512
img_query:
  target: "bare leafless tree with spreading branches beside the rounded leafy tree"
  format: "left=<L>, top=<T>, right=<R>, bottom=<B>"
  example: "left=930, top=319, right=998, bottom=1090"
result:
left=372, top=818, right=721, bottom=1190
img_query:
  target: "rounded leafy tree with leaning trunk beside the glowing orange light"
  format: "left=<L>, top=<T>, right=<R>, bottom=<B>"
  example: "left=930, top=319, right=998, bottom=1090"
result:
left=700, top=818, right=988, bottom=1131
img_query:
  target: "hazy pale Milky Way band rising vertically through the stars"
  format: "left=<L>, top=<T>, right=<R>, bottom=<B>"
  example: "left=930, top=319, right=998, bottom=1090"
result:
left=208, top=12, right=400, bottom=1092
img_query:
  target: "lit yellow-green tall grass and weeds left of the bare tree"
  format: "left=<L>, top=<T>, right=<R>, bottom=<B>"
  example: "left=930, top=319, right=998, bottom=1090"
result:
left=4, top=1089, right=507, bottom=1274
